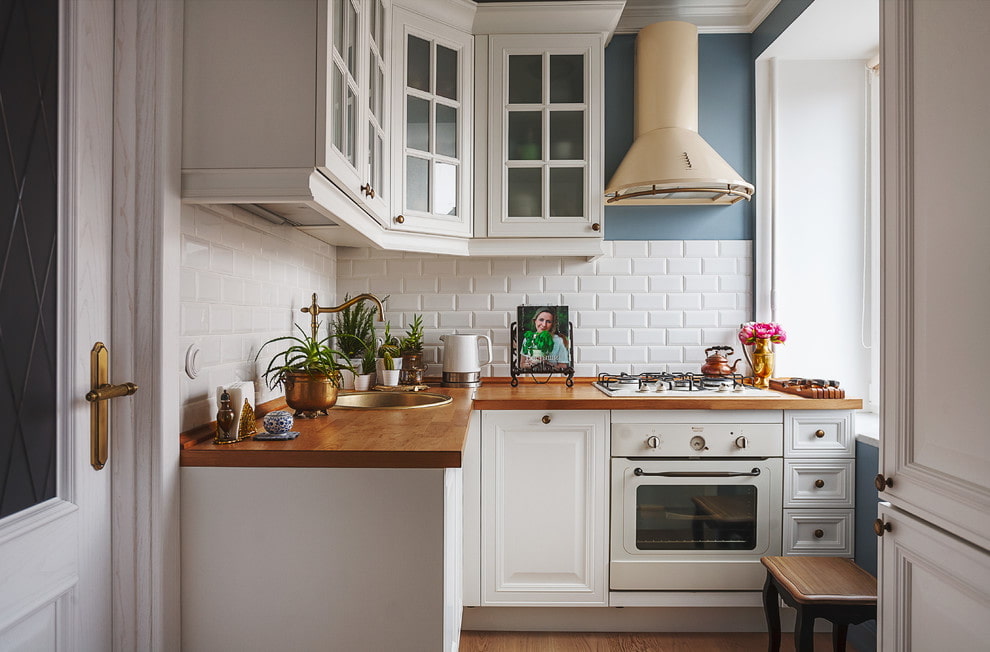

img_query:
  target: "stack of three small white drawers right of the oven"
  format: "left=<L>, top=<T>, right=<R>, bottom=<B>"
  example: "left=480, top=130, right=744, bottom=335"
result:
left=782, top=410, right=856, bottom=557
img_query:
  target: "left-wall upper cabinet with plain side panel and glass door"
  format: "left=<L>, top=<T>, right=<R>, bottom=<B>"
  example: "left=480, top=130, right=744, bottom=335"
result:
left=182, top=0, right=390, bottom=228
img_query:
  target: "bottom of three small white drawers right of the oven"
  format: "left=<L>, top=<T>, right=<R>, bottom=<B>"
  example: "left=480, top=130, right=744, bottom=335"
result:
left=783, top=509, right=855, bottom=557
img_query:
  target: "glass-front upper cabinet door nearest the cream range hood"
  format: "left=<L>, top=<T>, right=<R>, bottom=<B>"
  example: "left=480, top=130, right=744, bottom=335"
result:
left=488, top=34, right=604, bottom=238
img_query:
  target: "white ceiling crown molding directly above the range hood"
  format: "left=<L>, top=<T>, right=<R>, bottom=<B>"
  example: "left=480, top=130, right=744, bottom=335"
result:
left=615, top=0, right=780, bottom=34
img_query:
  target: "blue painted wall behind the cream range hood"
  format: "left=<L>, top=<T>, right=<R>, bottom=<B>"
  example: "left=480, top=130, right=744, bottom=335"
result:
left=605, top=34, right=759, bottom=240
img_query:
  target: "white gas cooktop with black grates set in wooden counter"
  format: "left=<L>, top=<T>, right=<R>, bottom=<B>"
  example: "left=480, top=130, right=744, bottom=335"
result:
left=592, top=372, right=779, bottom=398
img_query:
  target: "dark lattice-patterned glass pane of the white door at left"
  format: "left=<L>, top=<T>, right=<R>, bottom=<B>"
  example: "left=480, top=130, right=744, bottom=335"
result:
left=0, top=0, right=59, bottom=518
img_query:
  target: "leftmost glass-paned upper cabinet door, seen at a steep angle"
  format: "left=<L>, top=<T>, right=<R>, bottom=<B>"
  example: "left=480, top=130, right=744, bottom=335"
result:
left=320, top=0, right=390, bottom=223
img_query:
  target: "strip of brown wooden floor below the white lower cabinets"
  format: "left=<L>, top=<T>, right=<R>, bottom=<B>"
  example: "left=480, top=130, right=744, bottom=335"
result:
left=460, top=631, right=856, bottom=652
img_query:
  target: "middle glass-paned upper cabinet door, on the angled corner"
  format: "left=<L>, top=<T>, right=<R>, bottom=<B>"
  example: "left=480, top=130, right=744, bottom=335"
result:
left=391, top=7, right=473, bottom=236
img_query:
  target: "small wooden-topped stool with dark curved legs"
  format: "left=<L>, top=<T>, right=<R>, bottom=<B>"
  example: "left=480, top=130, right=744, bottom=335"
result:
left=760, top=557, right=877, bottom=652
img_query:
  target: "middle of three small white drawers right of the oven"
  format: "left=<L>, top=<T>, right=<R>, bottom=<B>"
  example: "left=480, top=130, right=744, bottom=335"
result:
left=784, top=459, right=856, bottom=509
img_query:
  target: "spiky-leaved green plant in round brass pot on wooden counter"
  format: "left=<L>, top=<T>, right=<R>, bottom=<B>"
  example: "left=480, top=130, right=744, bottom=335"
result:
left=255, top=324, right=353, bottom=418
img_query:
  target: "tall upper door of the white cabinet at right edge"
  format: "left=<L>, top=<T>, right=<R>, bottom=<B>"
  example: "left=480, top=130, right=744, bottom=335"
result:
left=880, top=0, right=990, bottom=549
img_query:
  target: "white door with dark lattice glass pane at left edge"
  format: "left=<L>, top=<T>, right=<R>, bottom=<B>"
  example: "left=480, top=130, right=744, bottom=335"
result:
left=0, top=0, right=113, bottom=652
